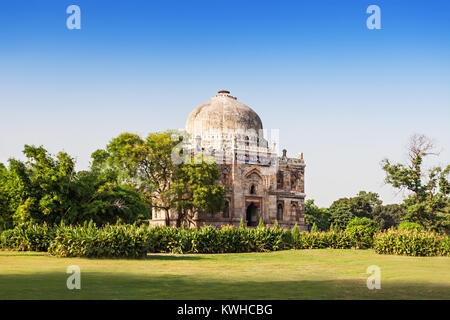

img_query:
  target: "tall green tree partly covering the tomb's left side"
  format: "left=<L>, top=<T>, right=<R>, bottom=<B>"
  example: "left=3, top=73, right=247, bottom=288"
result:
left=92, top=131, right=225, bottom=227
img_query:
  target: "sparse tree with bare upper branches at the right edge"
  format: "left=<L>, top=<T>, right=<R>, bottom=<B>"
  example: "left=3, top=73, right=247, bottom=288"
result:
left=382, top=134, right=450, bottom=233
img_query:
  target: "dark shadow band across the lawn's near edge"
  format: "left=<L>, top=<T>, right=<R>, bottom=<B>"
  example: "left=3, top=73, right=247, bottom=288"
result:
left=0, top=270, right=450, bottom=300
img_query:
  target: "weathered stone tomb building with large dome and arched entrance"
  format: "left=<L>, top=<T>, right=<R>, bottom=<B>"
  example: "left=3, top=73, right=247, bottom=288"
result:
left=151, top=90, right=307, bottom=231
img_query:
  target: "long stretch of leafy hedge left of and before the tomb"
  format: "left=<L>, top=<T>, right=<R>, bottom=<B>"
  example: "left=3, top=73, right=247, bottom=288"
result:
left=0, top=223, right=292, bottom=258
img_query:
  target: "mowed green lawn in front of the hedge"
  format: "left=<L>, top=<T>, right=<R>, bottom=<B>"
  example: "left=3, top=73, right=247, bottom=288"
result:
left=0, top=249, right=450, bottom=299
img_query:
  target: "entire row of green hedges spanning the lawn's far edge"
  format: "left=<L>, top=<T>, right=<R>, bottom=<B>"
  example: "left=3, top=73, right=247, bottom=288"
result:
left=0, top=224, right=450, bottom=258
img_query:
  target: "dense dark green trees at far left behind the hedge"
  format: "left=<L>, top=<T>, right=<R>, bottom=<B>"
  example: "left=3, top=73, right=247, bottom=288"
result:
left=0, top=145, right=148, bottom=228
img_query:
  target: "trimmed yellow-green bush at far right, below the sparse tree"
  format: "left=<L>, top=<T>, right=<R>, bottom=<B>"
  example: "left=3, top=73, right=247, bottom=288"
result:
left=373, top=229, right=450, bottom=256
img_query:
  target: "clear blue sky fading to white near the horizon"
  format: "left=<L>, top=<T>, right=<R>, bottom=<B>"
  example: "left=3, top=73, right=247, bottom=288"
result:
left=0, top=0, right=450, bottom=206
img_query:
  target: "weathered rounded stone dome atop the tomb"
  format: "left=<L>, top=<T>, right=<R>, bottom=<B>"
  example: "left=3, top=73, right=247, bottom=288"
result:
left=186, top=90, right=263, bottom=138
